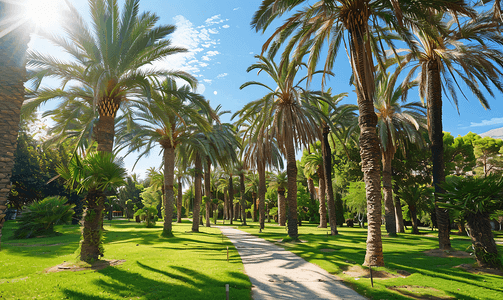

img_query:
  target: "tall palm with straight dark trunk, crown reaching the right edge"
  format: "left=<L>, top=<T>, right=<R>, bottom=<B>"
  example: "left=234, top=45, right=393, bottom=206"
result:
left=396, top=12, right=503, bottom=250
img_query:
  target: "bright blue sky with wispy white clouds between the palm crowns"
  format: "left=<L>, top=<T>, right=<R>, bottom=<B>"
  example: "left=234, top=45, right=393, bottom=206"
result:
left=25, top=0, right=503, bottom=176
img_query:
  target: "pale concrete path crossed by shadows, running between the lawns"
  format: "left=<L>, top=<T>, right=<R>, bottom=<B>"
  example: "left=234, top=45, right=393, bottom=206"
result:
left=215, top=226, right=366, bottom=300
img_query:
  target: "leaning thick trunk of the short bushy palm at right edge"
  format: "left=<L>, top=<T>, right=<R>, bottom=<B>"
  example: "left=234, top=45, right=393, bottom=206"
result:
left=466, top=213, right=502, bottom=268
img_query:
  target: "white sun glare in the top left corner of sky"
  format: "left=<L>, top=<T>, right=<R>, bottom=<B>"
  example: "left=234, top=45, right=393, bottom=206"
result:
left=26, top=0, right=64, bottom=31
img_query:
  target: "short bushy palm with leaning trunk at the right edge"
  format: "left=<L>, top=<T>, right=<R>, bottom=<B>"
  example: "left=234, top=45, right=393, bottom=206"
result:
left=440, top=175, right=503, bottom=268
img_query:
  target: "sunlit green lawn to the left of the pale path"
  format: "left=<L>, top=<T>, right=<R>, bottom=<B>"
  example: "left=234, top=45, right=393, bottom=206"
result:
left=0, top=220, right=251, bottom=300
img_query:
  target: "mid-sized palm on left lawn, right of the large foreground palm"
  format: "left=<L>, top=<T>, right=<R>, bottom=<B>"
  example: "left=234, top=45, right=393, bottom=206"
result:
left=119, top=78, right=211, bottom=236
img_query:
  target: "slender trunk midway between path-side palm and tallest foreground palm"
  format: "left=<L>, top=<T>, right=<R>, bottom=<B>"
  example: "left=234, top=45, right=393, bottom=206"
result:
left=321, top=125, right=339, bottom=235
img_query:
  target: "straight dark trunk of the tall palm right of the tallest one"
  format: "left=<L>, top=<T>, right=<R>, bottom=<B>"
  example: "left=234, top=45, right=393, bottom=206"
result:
left=427, top=60, right=452, bottom=250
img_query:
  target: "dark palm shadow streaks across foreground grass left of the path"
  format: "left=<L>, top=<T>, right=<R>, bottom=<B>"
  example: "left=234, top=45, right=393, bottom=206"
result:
left=63, top=262, right=251, bottom=300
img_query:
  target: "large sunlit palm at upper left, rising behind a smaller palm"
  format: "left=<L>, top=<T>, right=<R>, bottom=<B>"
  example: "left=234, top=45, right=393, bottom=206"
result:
left=28, top=0, right=195, bottom=152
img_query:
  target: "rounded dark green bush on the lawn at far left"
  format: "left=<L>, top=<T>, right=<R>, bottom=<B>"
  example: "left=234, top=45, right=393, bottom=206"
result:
left=14, top=196, right=75, bottom=239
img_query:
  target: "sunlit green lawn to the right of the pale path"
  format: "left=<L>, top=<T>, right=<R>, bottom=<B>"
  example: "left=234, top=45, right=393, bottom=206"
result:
left=229, top=218, right=503, bottom=299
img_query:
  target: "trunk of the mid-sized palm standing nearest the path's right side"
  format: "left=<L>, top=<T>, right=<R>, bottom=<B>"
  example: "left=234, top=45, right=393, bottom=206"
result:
left=285, top=132, right=299, bottom=239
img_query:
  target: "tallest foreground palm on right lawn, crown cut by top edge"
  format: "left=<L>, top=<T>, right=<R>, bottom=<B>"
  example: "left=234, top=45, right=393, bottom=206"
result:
left=251, top=0, right=469, bottom=266
